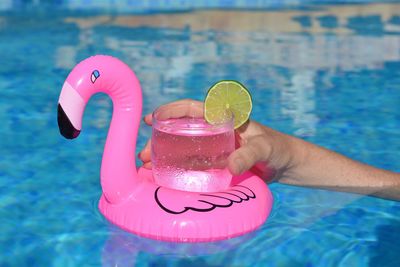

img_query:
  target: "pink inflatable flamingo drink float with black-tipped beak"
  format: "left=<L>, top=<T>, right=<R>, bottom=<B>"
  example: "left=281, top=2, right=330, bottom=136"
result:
left=58, top=55, right=272, bottom=242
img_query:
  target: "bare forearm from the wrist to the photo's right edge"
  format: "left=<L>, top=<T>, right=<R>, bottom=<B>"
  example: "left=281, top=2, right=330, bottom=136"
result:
left=279, top=137, right=400, bottom=200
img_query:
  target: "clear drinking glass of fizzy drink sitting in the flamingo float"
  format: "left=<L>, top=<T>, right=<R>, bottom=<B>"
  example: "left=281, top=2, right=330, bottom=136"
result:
left=151, top=103, right=235, bottom=192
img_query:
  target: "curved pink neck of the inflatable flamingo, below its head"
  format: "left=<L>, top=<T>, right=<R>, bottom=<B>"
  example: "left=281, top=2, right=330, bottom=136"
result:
left=100, top=68, right=142, bottom=204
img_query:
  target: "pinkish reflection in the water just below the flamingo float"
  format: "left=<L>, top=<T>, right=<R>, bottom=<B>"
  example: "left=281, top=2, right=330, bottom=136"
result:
left=101, top=226, right=255, bottom=266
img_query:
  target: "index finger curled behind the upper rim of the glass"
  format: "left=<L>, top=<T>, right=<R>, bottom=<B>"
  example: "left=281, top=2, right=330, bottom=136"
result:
left=143, top=99, right=204, bottom=125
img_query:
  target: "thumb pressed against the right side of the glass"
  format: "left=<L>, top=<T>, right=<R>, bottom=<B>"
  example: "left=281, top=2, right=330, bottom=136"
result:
left=228, top=136, right=270, bottom=176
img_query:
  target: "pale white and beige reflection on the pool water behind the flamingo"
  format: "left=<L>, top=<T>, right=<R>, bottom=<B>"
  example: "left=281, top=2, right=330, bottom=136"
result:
left=51, top=4, right=400, bottom=136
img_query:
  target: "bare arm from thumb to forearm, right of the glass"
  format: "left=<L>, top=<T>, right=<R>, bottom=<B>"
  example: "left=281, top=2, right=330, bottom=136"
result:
left=229, top=122, right=400, bottom=200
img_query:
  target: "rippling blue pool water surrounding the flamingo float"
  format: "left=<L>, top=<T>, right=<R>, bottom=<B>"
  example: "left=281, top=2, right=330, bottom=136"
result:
left=0, top=1, right=400, bottom=267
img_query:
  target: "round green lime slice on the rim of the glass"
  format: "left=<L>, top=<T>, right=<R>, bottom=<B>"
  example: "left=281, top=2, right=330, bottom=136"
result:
left=204, top=81, right=253, bottom=129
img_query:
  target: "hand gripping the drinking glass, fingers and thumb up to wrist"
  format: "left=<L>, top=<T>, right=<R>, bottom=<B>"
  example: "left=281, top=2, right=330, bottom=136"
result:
left=139, top=99, right=295, bottom=183
